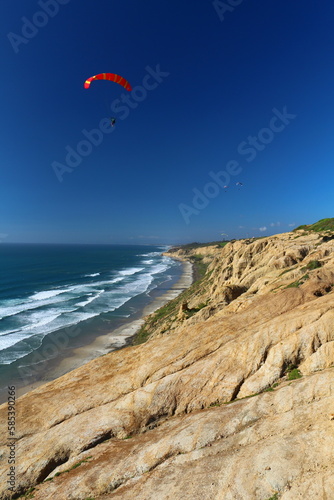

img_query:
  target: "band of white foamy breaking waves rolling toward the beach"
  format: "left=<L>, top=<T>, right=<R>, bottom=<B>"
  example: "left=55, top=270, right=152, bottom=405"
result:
left=0, top=252, right=175, bottom=364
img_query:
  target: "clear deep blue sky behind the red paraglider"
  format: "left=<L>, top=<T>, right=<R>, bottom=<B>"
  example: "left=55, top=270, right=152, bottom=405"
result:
left=0, top=0, right=334, bottom=244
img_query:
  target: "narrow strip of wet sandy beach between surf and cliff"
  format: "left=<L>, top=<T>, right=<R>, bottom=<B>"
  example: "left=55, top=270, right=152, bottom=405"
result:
left=16, top=257, right=194, bottom=397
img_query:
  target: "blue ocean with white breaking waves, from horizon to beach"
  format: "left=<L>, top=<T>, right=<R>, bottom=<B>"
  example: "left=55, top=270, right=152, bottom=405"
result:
left=0, top=244, right=182, bottom=398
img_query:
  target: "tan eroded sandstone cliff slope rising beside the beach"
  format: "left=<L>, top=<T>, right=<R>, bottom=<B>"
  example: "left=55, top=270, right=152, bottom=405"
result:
left=0, top=225, right=334, bottom=500
